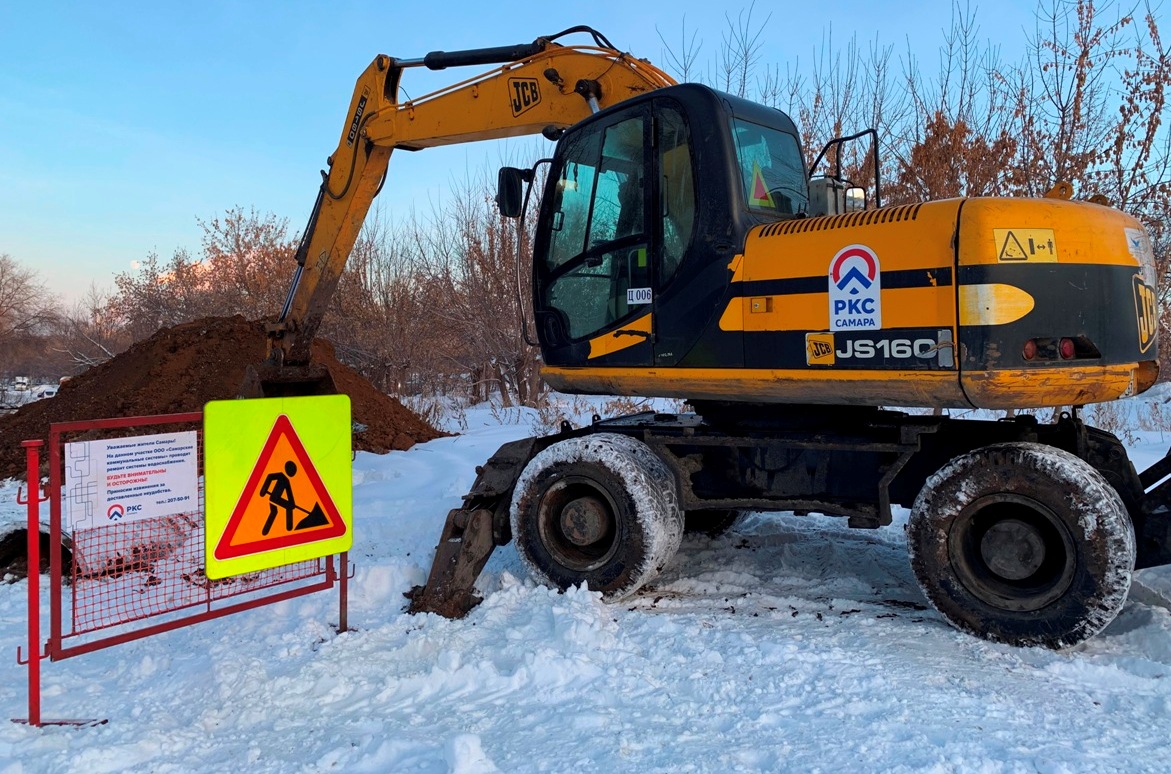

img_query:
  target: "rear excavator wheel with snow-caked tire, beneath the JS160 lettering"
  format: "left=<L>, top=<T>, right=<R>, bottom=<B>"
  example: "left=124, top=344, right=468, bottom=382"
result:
left=908, top=444, right=1135, bottom=648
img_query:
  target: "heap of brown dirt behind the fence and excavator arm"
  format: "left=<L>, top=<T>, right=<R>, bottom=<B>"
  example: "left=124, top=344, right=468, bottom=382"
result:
left=0, top=315, right=444, bottom=480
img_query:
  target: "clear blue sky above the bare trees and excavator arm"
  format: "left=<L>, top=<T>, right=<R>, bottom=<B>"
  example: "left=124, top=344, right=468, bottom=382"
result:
left=0, top=0, right=1034, bottom=302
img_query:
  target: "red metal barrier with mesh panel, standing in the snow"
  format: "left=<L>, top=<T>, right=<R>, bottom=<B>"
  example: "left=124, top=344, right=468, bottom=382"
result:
left=18, top=412, right=349, bottom=725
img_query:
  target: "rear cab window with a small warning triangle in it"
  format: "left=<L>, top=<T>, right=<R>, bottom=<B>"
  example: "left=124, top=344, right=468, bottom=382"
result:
left=732, top=118, right=808, bottom=215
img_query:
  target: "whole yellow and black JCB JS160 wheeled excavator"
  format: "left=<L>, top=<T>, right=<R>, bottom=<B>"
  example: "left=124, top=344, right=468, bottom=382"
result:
left=252, top=27, right=1171, bottom=648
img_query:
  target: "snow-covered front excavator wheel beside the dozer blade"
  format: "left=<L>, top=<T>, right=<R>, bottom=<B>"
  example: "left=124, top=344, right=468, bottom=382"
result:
left=512, top=433, right=683, bottom=601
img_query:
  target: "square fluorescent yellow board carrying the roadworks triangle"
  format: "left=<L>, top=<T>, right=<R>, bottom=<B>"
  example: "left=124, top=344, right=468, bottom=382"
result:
left=205, top=396, right=352, bottom=578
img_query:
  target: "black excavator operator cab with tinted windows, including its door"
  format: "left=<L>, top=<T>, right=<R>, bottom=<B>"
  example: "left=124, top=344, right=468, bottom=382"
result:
left=533, top=84, right=808, bottom=367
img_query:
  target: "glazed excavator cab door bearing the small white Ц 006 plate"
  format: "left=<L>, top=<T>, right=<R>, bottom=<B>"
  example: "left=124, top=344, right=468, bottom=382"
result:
left=536, top=105, right=655, bottom=365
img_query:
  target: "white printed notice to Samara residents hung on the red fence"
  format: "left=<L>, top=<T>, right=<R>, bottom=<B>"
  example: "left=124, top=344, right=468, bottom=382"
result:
left=63, top=431, right=199, bottom=529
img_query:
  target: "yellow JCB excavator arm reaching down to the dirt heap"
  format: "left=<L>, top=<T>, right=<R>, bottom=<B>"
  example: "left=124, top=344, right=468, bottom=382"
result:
left=241, top=27, right=674, bottom=397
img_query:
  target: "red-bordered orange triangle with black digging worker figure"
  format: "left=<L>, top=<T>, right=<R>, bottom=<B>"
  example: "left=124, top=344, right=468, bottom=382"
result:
left=214, top=413, right=345, bottom=561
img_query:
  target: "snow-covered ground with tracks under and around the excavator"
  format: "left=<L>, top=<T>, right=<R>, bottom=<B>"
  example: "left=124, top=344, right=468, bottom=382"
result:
left=0, top=412, right=1171, bottom=774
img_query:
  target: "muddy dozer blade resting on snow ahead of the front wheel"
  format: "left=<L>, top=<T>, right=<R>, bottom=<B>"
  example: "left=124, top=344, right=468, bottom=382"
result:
left=406, top=508, right=495, bottom=618
